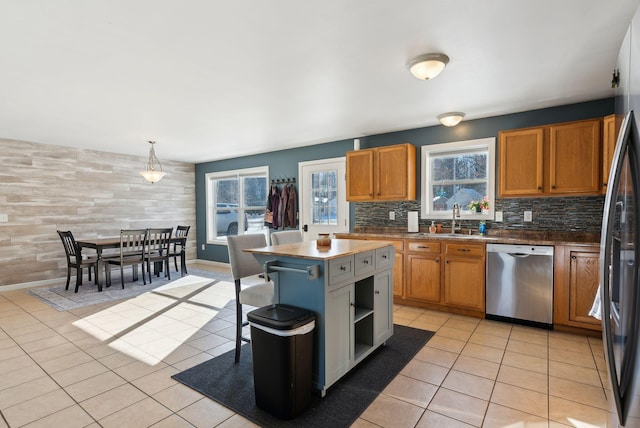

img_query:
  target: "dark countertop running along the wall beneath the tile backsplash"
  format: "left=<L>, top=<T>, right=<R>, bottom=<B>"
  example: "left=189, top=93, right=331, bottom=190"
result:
left=336, top=227, right=600, bottom=246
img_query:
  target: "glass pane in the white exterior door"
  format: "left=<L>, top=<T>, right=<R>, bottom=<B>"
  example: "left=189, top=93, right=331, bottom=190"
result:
left=311, top=170, right=338, bottom=225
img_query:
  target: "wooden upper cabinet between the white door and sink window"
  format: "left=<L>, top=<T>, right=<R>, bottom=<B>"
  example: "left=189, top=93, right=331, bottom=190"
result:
left=347, top=144, right=416, bottom=202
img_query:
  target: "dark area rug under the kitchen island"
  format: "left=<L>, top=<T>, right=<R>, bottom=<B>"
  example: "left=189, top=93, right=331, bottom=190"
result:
left=173, top=325, right=433, bottom=428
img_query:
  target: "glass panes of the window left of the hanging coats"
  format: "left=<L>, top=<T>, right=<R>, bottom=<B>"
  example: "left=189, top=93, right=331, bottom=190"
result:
left=214, top=175, right=267, bottom=238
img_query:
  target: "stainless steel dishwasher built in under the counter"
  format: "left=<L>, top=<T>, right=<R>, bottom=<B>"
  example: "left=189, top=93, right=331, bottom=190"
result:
left=486, top=244, right=553, bottom=329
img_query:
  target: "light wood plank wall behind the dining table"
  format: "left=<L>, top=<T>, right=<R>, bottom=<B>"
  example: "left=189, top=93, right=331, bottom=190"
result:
left=0, top=139, right=196, bottom=291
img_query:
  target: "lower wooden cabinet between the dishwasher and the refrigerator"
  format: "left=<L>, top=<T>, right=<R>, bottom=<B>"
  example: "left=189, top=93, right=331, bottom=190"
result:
left=553, top=245, right=601, bottom=330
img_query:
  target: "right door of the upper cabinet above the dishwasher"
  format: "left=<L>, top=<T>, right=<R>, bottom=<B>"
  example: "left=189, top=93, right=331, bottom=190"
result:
left=549, top=119, right=602, bottom=194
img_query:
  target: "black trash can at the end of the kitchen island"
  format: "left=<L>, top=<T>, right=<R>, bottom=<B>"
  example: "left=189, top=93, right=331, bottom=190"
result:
left=247, top=304, right=316, bottom=419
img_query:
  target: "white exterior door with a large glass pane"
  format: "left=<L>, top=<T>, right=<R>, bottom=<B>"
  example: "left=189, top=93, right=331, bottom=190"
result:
left=298, top=157, right=349, bottom=241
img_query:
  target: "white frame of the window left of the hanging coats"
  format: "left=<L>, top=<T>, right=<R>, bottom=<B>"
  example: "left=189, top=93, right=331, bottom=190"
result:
left=205, top=166, right=269, bottom=245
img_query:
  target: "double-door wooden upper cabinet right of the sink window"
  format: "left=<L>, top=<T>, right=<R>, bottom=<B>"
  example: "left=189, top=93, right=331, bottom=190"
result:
left=498, top=119, right=602, bottom=197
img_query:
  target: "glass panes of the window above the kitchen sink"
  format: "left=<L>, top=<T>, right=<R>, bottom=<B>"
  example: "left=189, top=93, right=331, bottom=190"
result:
left=430, top=152, right=488, bottom=212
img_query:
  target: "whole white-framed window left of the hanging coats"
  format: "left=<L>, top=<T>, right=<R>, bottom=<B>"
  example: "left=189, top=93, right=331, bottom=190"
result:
left=206, top=166, right=269, bottom=243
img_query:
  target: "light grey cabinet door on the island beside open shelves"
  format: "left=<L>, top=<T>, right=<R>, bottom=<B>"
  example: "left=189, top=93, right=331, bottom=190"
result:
left=325, top=284, right=355, bottom=385
